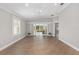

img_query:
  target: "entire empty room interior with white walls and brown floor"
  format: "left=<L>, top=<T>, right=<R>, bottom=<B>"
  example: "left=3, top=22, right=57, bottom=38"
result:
left=0, top=3, right=79, bottom=55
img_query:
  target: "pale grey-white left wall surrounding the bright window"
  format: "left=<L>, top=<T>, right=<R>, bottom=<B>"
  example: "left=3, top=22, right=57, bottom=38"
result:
left=0, top=9, right=26, bottom=49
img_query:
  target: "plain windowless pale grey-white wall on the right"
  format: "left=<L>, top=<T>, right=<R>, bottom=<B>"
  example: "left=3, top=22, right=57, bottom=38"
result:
left=59, top=3, right=79, bottom=49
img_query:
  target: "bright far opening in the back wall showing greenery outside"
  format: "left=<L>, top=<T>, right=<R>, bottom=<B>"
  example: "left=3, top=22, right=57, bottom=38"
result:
left=33, top=24, right=47, bottom=35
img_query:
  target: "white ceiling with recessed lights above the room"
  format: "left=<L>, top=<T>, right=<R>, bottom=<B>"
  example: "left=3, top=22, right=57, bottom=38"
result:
left=0, top=3, right=69, bottom=19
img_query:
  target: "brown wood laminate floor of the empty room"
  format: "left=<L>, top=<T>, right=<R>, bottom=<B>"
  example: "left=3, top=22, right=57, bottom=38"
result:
left=0, top=36, right=79, bottom=55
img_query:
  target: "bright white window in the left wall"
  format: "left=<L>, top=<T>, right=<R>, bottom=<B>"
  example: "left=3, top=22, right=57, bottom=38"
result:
left=13, top=18, right=21, bottom=35
